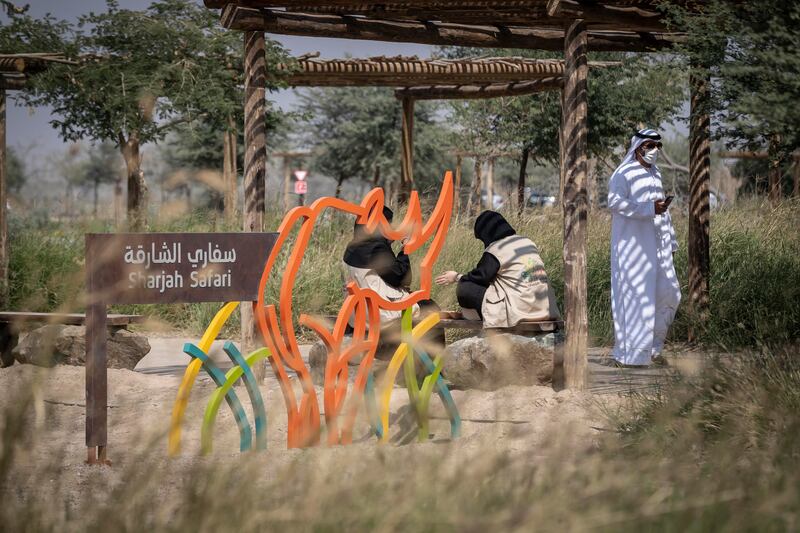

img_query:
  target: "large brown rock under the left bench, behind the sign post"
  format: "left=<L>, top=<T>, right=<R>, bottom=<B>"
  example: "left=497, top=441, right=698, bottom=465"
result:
left=13, top=324, right=150, bottom=370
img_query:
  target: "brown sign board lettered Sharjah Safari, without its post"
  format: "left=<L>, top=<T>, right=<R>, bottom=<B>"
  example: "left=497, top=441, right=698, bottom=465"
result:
left=86, top=233, right=277, bottom=304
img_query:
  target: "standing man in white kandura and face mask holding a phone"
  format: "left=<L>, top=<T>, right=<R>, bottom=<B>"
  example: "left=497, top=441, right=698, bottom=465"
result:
left=608, top=129, right=681, bottom=366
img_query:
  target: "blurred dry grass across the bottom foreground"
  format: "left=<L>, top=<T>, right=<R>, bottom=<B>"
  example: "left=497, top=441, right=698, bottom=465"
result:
left=0, top=342, right=800, bottom=532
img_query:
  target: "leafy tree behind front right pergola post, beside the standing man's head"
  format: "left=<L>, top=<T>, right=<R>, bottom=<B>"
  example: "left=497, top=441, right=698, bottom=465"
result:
left=442, top=48, right=686, bottom=210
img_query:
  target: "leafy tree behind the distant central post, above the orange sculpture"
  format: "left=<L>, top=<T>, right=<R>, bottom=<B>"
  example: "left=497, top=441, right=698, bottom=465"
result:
left=299, top=87, right=450, bottom=196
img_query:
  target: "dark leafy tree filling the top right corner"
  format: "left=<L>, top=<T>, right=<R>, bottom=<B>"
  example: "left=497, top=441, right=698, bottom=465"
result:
left=663, top=0, right=800, bottom=197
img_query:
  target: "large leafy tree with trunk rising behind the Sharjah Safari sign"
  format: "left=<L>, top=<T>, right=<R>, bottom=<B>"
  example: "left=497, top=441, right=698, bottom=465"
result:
left=0, top=0, right=284, bottom=228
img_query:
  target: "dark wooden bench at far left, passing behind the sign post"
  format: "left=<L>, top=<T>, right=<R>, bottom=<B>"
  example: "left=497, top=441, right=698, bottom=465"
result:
left=0, top=311, right=145, bottom=367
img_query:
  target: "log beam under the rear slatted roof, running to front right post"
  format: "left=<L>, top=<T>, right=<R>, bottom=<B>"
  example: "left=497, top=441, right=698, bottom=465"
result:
left=394, top=77, right=564, bottom=100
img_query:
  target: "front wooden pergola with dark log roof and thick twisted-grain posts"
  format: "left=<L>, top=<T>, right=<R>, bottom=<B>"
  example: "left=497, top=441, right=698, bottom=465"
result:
left=204, top=0, right=711, bottom=389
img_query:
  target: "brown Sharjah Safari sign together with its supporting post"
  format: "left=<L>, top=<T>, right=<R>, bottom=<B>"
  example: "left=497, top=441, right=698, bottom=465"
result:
left=86, top=233, right=277, bottom=463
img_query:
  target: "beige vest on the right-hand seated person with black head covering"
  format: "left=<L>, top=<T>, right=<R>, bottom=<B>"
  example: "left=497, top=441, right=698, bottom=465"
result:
left=481, top=235, right=561, bottom=328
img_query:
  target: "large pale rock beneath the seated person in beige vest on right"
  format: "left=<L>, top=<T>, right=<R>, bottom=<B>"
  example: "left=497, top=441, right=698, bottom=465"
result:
left=443, top=333, right=558, bottom=390
